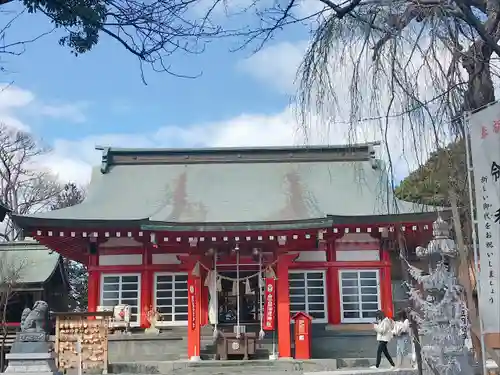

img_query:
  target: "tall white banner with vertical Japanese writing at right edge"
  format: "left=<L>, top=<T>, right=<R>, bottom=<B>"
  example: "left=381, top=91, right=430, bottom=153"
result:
left=469, top=103, right=500, bottom=333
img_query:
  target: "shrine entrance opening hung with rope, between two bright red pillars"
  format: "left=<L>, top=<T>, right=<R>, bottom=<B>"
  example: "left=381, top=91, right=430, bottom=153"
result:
left=200, top=244, right=276, bottom=360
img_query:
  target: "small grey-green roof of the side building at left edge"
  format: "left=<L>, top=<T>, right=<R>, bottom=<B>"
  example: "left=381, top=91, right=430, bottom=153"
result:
left=0, top=241, right=60, bottom=284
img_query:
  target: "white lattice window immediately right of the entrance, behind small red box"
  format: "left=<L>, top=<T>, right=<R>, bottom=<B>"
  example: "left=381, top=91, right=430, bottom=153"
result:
left=288, top=270, right=328, bottom=323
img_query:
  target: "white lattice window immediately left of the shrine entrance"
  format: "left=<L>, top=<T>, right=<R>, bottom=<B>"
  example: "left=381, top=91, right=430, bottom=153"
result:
left=154, top=273, right=188, bottom=326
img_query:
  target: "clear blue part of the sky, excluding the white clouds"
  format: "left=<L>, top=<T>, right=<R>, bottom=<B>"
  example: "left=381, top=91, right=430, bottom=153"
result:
left=3, top=2, right=298, bottom=139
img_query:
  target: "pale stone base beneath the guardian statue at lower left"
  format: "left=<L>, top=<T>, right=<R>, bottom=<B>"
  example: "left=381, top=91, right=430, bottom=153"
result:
left=5, top=353, right=59, bottom=375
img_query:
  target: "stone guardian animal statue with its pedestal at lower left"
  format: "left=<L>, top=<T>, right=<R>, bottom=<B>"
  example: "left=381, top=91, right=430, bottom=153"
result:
left=5, top=301, right=59, bottom=375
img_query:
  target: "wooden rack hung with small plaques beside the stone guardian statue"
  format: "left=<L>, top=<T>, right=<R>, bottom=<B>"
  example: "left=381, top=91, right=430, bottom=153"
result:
left=53, top=311, right=113, bottom=374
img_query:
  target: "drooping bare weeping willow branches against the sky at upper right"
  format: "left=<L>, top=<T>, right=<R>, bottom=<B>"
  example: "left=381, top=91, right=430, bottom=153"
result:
left=298, top=0, right=500, bottom=212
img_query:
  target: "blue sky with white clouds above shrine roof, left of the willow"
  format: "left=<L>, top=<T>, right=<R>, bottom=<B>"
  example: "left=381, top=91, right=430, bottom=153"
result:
left=0, top=0, right=422, bottom=183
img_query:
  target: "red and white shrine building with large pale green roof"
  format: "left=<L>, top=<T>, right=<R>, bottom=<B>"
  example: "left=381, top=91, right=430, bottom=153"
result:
left=13, top=144, right=437, bottom=357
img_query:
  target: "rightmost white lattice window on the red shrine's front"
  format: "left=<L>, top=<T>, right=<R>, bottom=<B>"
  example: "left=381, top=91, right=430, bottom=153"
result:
left=339, top=270, right=380, bottom=323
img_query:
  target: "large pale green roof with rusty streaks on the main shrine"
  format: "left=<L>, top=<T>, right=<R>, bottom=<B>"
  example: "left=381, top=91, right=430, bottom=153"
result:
left=10, top=145, right=442, bottom=229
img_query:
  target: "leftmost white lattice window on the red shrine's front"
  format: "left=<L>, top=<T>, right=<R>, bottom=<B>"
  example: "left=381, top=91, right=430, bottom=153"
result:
left=101, top=273, right=141, bottom=325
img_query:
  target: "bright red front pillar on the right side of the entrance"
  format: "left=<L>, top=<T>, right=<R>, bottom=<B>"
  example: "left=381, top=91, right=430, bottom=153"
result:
left=276, top=254, right=299, bottom=358
